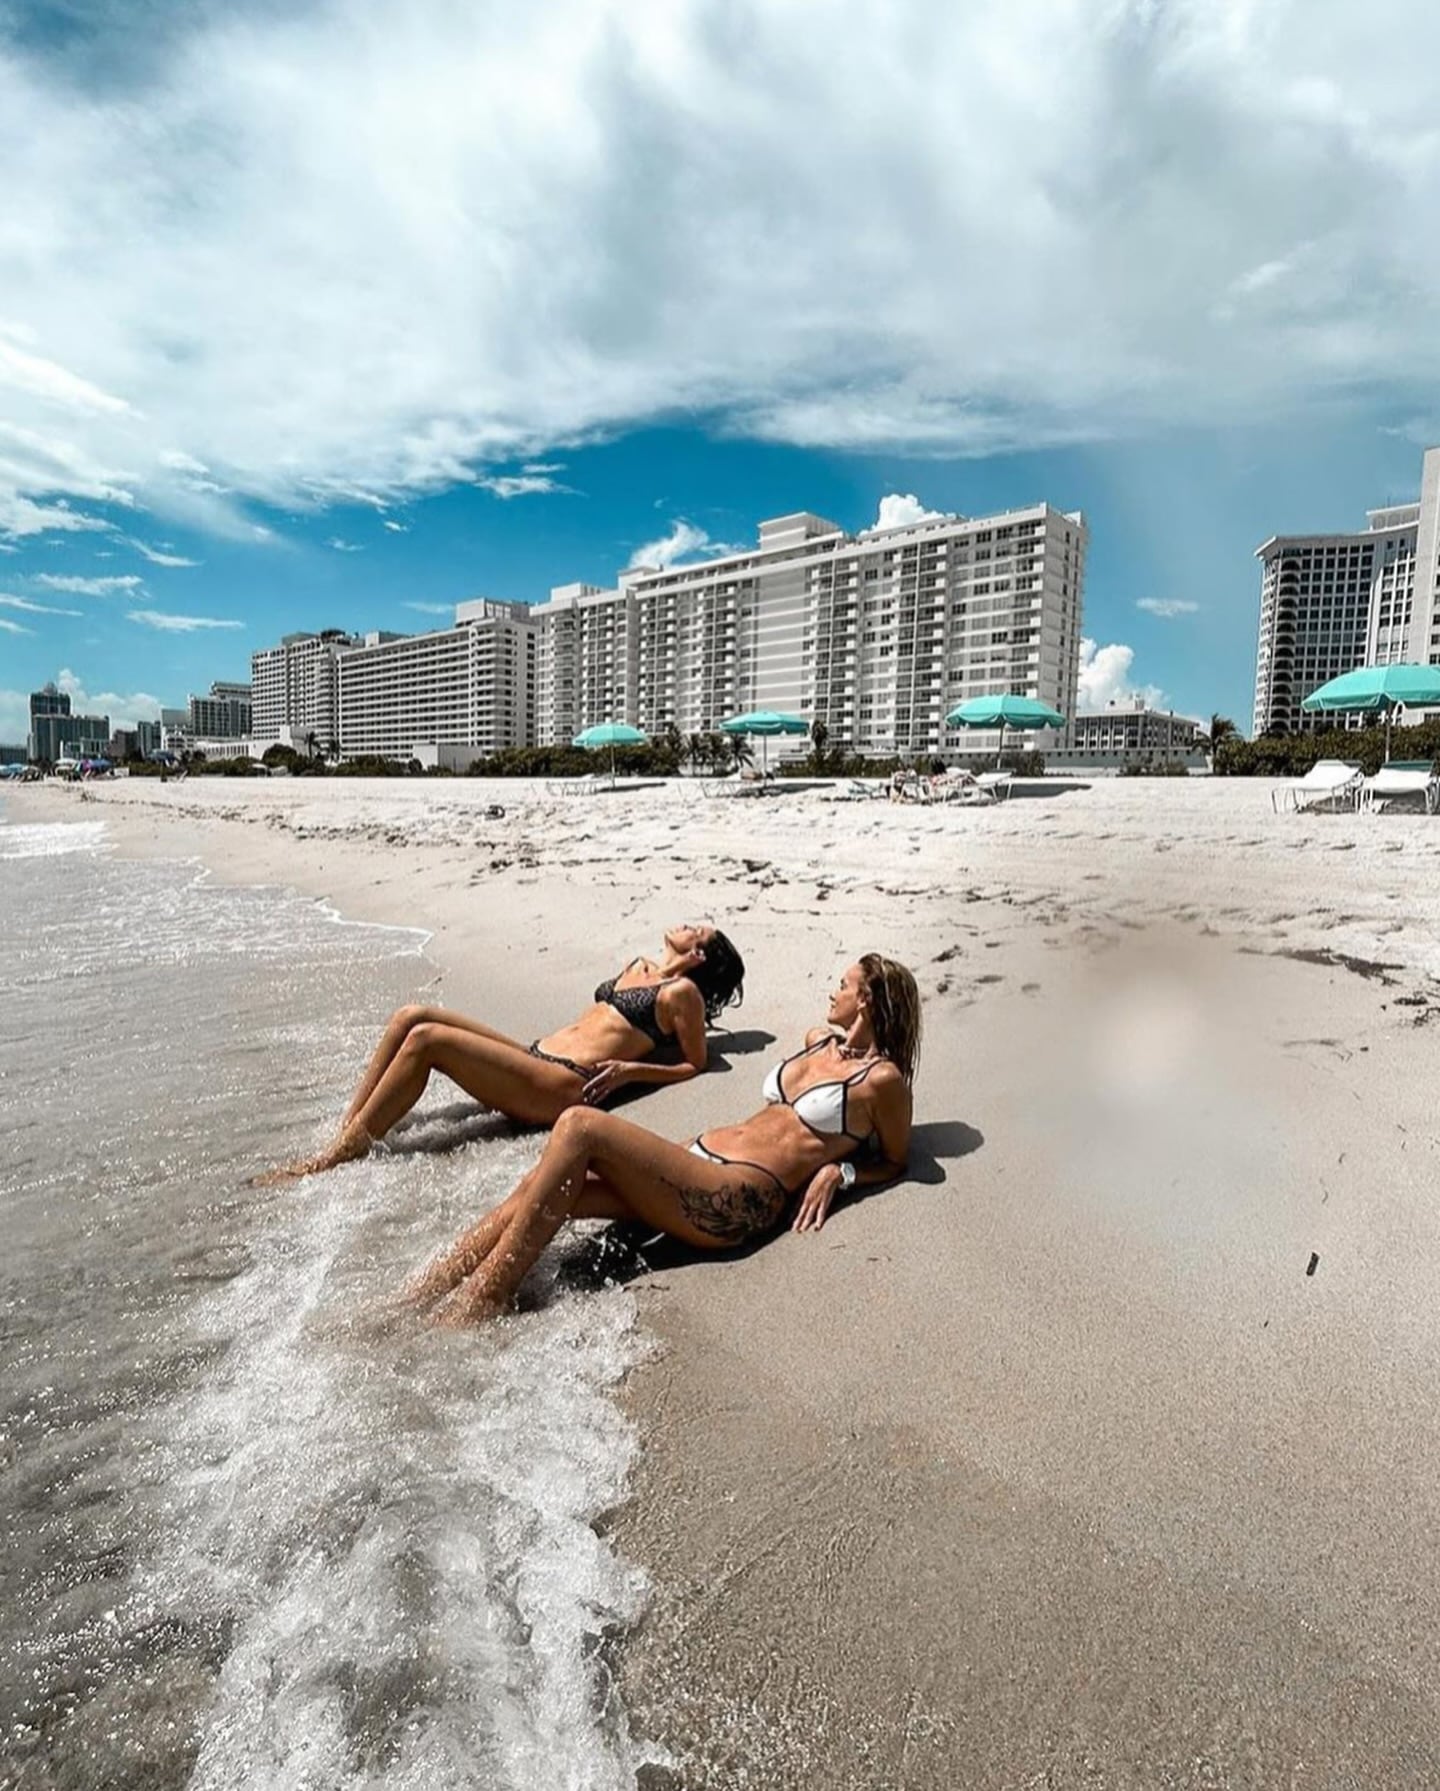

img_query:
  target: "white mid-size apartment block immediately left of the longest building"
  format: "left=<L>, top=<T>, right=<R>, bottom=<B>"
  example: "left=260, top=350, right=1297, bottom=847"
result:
left=335, top=598, right=539, bottom=763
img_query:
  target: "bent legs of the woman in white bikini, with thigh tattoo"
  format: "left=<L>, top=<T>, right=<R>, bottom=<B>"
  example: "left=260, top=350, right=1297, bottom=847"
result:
left=435, top=1107, right=784, bottom=1320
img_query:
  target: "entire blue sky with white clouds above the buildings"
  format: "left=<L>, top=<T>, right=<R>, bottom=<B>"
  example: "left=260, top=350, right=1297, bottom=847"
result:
left=0, top=0, right=1440, bottom=741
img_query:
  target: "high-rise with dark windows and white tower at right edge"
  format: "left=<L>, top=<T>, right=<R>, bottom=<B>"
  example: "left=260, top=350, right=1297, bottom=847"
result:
left=1254, top=448, right=1440, bottom=734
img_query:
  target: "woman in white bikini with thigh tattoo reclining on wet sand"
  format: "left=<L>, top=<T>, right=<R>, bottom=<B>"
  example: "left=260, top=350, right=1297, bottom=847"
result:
left=414, top=953, right=921, bottom=1324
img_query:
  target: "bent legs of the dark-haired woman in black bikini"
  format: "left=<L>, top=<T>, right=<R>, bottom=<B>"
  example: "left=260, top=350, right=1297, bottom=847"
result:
left=258, top=1021, right=586, bottom=1186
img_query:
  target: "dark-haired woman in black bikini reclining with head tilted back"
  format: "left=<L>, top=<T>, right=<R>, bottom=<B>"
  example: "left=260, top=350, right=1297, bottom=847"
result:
left=256, top=926, right=745, bottom=1186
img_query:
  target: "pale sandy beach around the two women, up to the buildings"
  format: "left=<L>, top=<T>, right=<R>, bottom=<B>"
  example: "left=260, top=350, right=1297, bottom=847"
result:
left=7, top=777, right=1440, bottom=1791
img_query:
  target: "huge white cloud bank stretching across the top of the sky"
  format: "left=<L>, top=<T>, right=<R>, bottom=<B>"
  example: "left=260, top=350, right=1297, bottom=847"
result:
left=0, top=0, right=1440, bottom=537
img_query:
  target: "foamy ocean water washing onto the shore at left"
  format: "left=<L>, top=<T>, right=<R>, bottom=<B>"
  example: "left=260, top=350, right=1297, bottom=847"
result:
left=0, top=810, right=654, bottom=1791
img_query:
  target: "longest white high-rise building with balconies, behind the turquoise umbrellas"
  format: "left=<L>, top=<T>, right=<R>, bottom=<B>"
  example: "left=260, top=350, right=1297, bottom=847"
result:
left=536, top=503, right=1087, bottom=752
